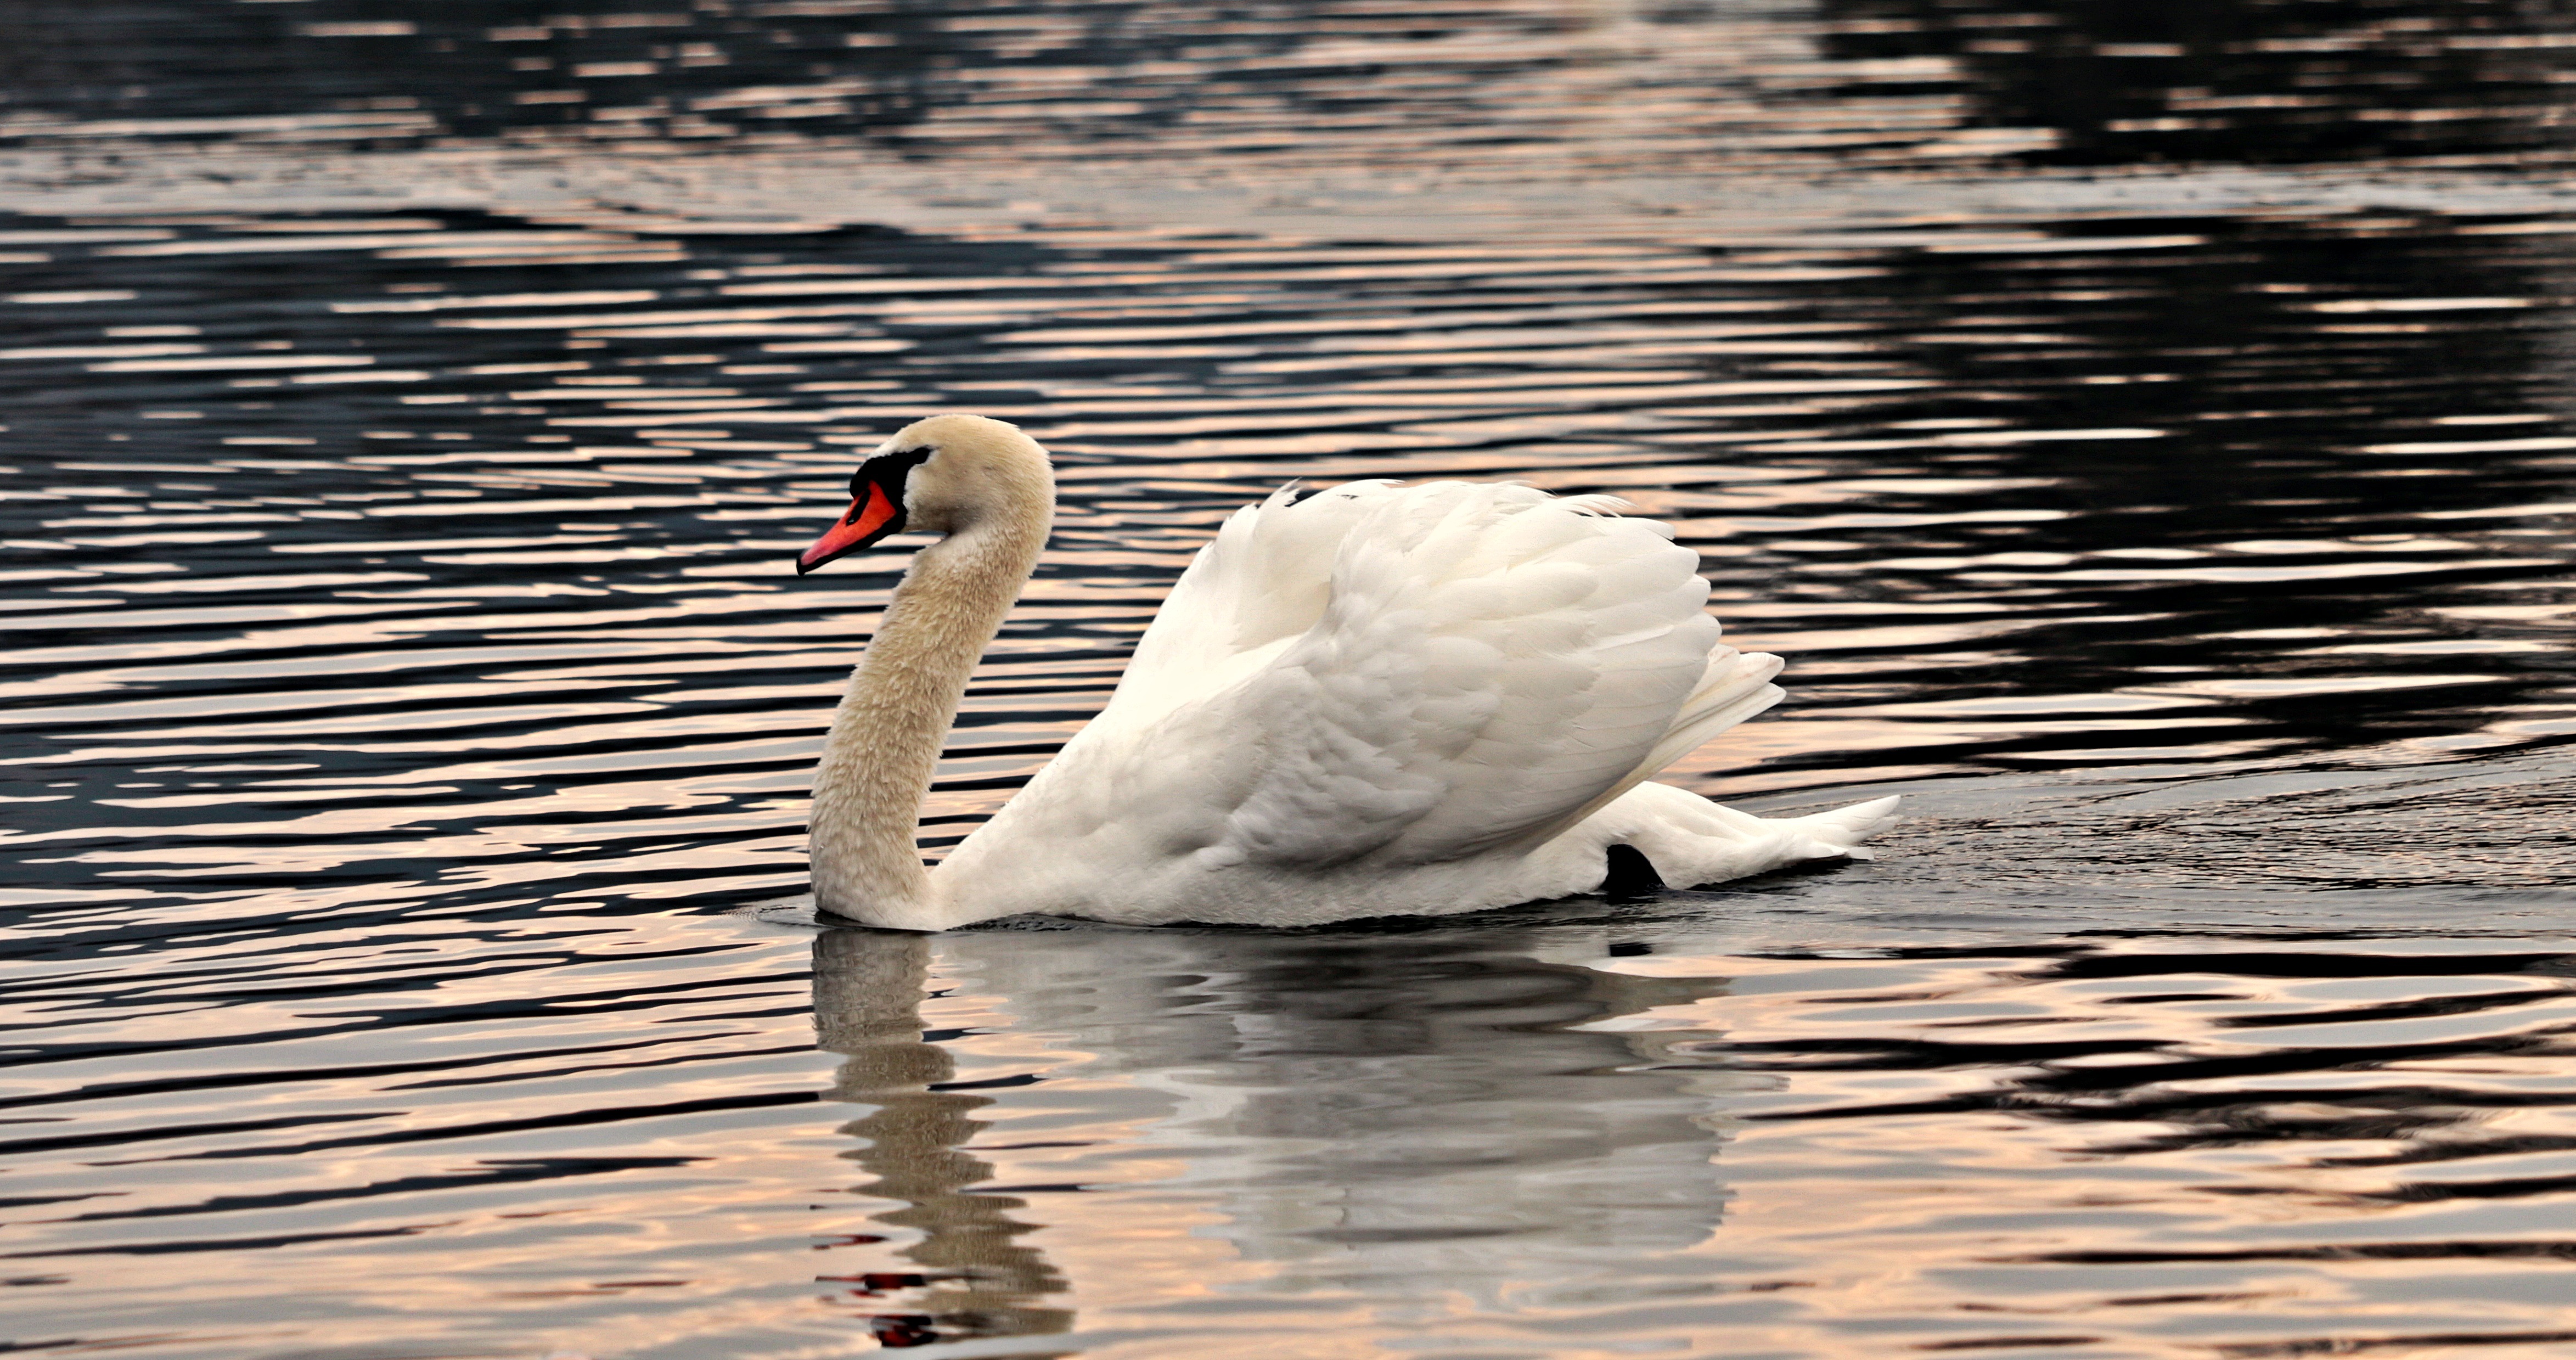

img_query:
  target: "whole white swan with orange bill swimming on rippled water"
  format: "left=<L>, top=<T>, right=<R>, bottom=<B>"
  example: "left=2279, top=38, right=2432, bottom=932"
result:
left=796, top=415, right=1896, bottom=930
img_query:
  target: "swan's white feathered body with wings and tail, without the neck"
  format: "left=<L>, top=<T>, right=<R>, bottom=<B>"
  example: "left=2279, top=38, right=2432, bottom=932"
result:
left=935, top=482, right=1893, bottom=925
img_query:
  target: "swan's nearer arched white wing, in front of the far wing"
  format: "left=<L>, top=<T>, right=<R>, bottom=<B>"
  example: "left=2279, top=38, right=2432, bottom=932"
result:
left=1167, top=482, right=1767, bottom=866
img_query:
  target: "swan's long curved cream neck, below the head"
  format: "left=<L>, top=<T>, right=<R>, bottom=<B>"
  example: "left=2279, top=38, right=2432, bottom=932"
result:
left=809, top=502, right=1051, bottom=930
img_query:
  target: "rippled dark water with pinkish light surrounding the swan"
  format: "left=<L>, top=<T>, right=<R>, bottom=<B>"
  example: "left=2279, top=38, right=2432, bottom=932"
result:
left=0, top=0, right=2576, bottom=1360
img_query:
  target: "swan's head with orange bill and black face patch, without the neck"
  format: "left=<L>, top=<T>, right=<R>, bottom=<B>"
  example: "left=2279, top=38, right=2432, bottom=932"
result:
left=796, top=415, right=1056, bottom=577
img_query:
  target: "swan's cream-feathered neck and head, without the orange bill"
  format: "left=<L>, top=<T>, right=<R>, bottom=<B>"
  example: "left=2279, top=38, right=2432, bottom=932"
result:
left=812, top=415, right=1056, bottom=930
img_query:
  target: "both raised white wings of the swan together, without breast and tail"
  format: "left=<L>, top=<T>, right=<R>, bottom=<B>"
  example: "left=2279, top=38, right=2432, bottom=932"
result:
left=1144, top=482, right=1778, bottom=868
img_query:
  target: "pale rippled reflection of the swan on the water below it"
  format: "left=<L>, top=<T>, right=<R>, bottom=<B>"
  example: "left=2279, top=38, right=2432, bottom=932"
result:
left=814, top=925, right=1775, bottom=1345
